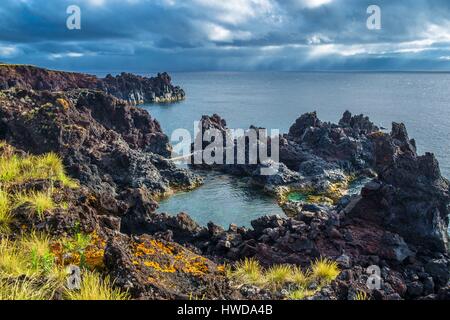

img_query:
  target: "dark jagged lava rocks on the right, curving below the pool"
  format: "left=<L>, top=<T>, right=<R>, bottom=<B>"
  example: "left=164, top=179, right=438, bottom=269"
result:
left=146, top=112, right=450, bottom=299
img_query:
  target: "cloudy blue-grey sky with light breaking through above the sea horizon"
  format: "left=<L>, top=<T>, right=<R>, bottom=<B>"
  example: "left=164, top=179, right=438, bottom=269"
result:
left=0, top=0, right=450, bottom=72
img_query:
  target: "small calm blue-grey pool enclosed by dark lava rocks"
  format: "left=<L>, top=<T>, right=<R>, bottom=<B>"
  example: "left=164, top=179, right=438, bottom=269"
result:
left=158, top=172, right=285, bottom=228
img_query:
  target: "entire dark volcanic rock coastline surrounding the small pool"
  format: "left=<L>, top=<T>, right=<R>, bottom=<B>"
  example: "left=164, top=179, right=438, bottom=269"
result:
left=0, top=66, right=450, bottom=300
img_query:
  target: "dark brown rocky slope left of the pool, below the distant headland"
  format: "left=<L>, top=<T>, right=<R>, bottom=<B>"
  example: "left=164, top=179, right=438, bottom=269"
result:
left=0, top=89, right=201, bottom=196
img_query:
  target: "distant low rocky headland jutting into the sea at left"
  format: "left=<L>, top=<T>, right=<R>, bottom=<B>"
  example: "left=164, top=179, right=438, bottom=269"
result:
left=0, top=64, right=185, bottom=104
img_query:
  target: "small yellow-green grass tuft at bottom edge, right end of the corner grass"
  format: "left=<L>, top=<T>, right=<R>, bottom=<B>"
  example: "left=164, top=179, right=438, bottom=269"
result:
left=65, top=271, right=129, bottom=300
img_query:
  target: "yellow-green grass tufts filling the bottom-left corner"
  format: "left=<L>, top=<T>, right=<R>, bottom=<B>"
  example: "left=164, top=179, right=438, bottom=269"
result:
left=0, top=234, right=129, bottom=300
